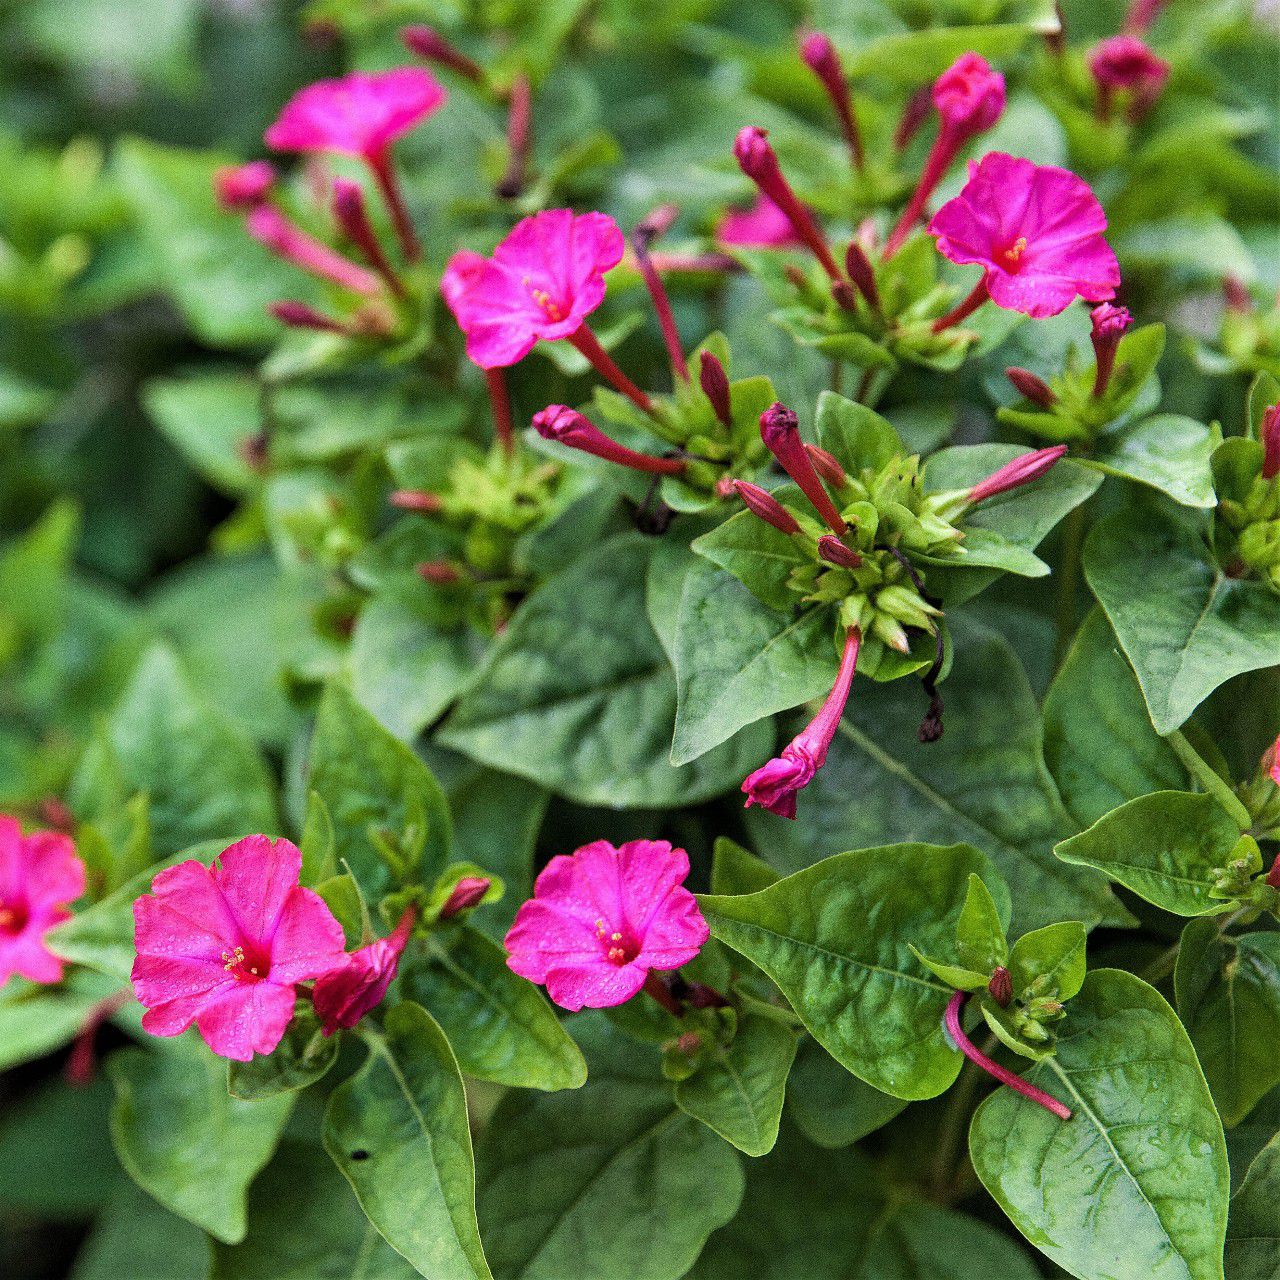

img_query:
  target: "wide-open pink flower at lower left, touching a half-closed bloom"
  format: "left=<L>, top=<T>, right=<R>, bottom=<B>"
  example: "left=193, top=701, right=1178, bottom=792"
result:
left=133, top=836, right=349, bottom=1062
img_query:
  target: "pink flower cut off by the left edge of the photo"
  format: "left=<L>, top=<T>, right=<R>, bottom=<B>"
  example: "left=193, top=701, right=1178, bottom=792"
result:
left=0, top=817, right=84, bottom=987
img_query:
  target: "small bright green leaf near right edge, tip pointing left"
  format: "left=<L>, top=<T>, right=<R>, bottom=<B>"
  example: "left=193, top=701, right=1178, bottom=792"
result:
left=1053, top=791, right=1240, bottom=915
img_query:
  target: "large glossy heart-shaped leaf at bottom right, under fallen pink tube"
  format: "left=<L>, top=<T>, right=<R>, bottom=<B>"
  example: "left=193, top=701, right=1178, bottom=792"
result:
left=969, top=969, right=1229, bottom=1280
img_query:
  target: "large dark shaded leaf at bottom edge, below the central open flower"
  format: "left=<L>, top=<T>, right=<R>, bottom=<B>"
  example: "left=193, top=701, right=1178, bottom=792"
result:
left=479, top=1014, right=742, bottom=1280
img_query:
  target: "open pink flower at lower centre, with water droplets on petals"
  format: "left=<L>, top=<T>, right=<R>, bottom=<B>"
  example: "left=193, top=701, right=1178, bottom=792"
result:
left=506, top=840, right=710, bottom=1010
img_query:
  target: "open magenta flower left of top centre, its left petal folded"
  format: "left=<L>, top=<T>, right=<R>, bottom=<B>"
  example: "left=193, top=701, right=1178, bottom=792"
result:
left=440, top=209, right=626, bottom=369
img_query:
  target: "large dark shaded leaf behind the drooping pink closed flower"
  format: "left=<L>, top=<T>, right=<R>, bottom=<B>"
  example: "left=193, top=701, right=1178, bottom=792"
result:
left=748, top=621, right=1126, bottom=931
